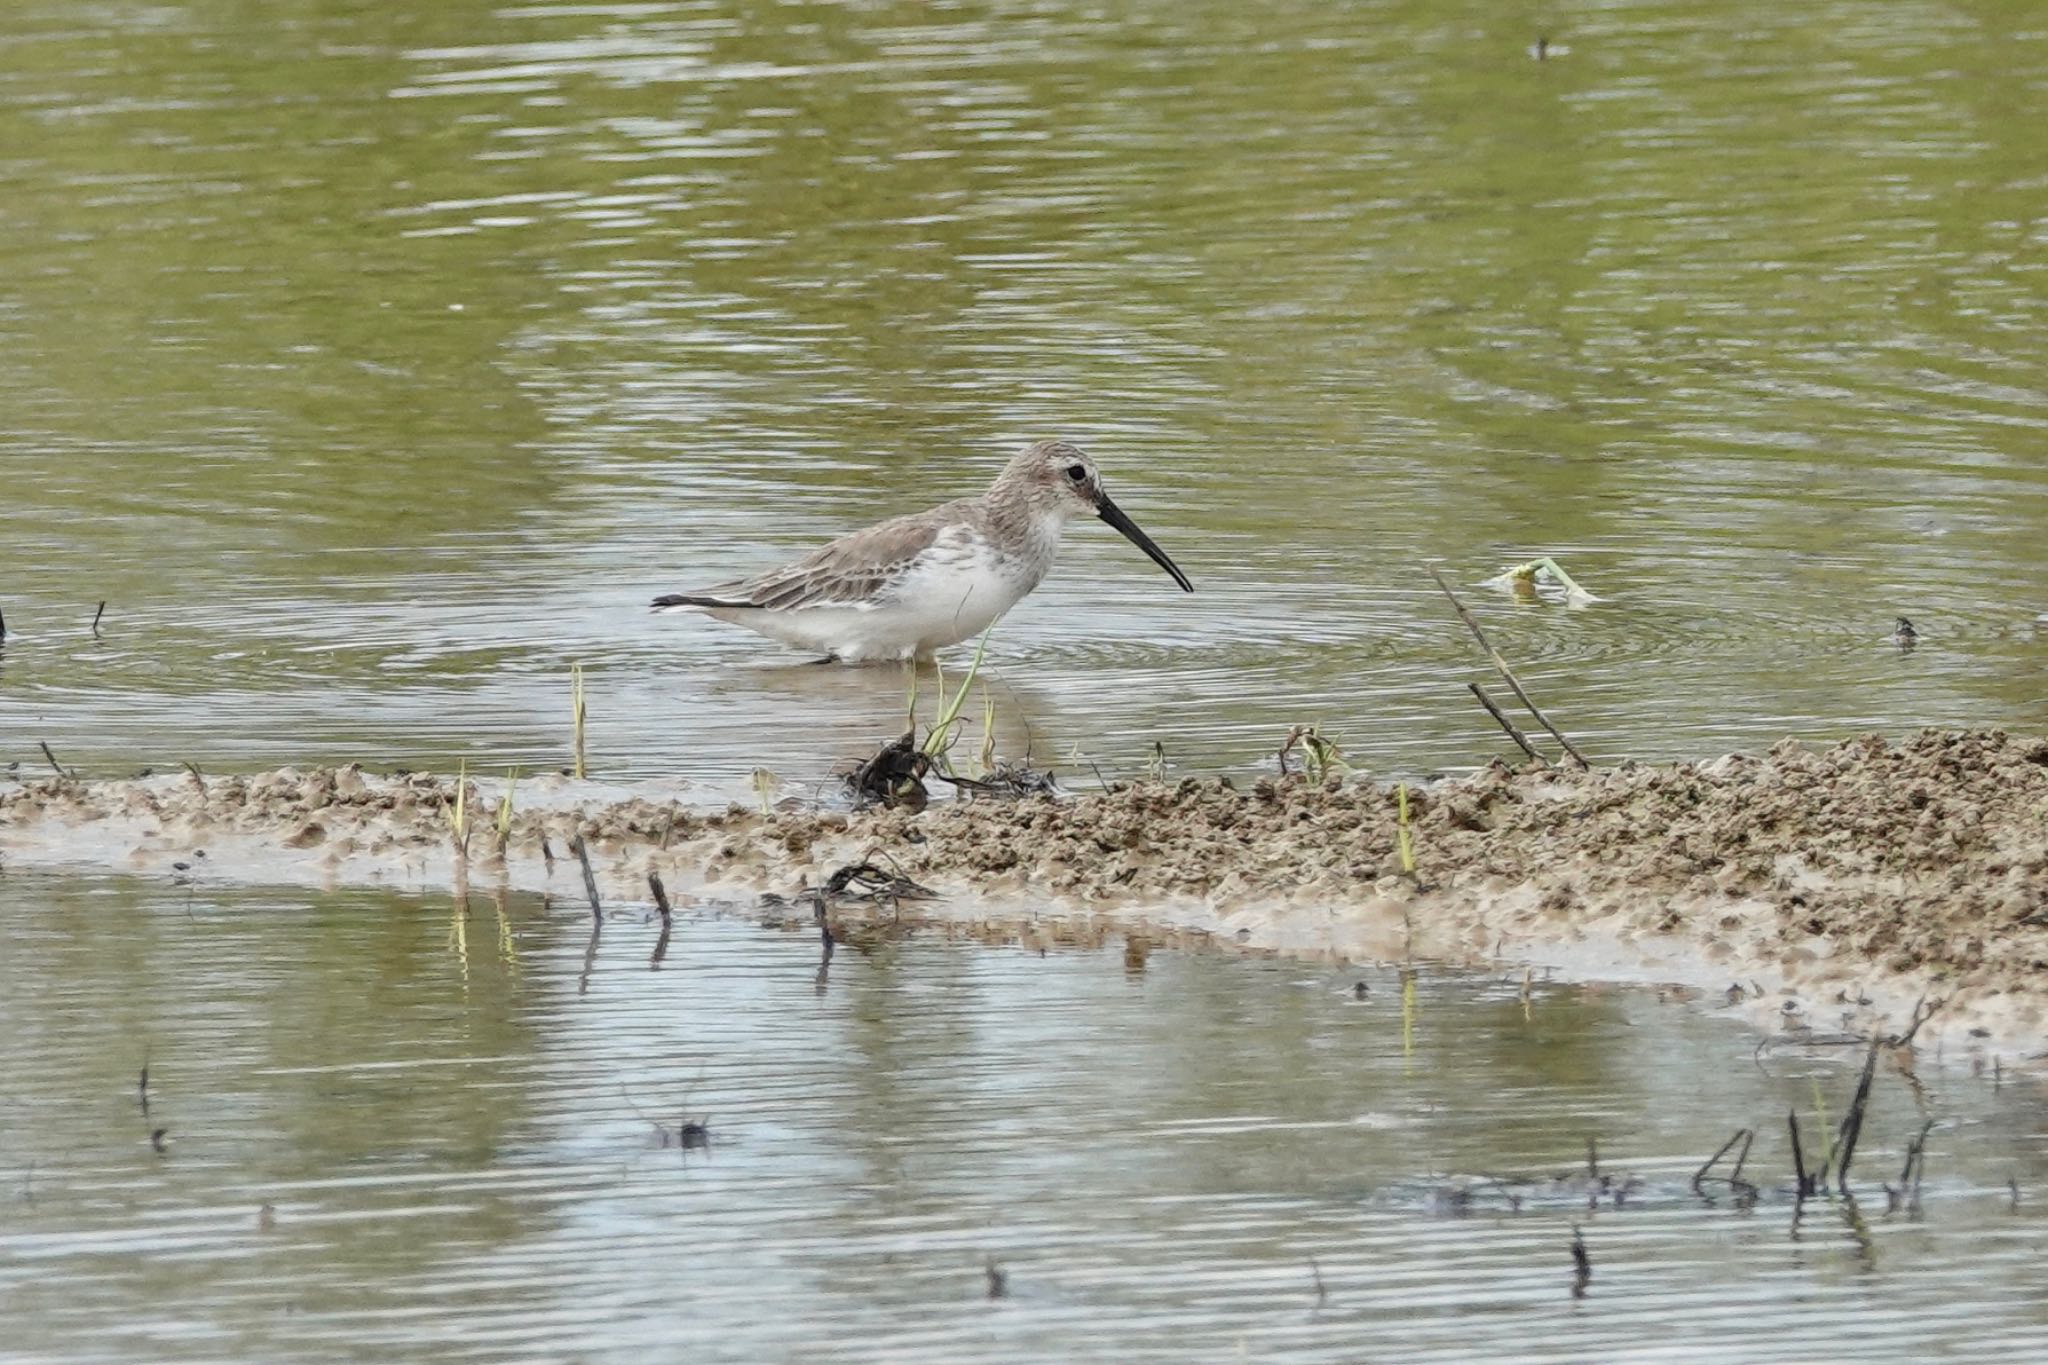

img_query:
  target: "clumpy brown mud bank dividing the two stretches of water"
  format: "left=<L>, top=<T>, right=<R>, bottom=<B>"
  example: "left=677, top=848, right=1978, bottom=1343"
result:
left=0, top=731, right=2048, bottom=1048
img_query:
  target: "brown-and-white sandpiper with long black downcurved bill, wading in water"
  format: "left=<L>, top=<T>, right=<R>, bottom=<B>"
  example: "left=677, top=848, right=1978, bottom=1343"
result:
left=653, top=440, right=1194, bottom=663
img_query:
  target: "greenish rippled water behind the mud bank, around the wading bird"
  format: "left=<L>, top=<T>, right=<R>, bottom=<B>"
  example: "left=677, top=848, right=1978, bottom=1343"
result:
left=0, top=0, right=2048, bottom=780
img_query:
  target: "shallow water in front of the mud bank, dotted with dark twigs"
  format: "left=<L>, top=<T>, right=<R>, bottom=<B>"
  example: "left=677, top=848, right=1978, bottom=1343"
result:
left=0, top=874, right=2048, bottom=1361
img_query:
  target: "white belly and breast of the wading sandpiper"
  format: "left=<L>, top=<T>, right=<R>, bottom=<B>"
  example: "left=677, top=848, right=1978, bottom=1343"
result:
left=711, top=555, right=1036, bottom=663
